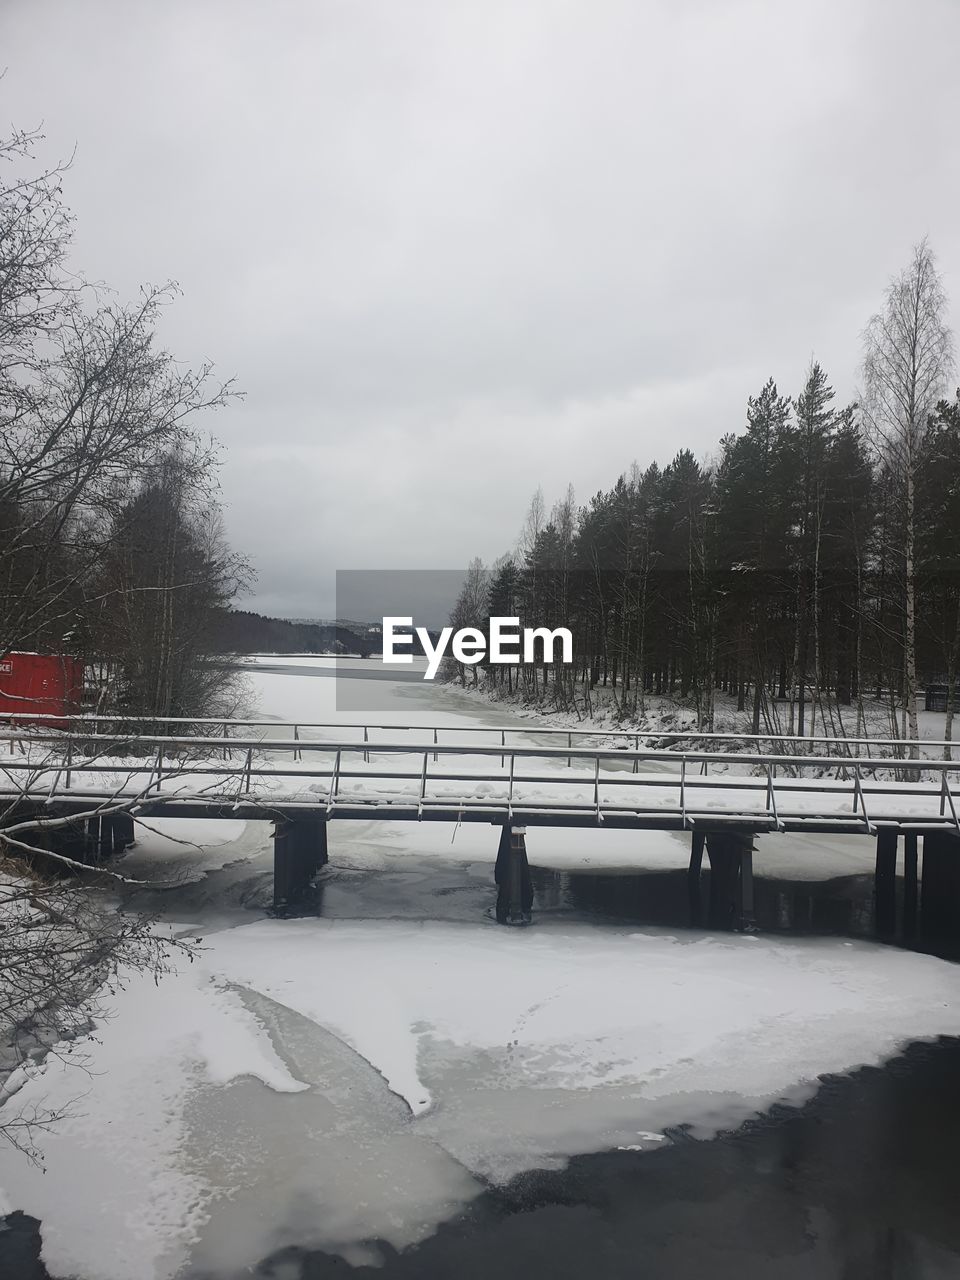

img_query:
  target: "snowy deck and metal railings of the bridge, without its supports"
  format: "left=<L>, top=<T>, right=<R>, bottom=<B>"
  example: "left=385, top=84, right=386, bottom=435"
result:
left=7, top=713, right=960, bottom=833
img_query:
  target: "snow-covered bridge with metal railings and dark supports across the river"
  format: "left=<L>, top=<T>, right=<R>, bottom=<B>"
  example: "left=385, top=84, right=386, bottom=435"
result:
left=0, top=713, right=960, bottom=936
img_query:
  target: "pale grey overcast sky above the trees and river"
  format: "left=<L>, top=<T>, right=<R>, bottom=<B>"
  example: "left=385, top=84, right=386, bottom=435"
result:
left=0, top=0, right=960, bottom=617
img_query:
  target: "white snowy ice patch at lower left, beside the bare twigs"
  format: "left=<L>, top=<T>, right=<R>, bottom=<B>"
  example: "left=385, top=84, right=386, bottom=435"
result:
left=0, top=964, right=306, bottom=1280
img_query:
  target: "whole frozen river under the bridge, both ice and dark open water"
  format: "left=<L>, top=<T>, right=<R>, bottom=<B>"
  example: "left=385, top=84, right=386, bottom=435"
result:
left=0, top=659, right=960, bottom=1280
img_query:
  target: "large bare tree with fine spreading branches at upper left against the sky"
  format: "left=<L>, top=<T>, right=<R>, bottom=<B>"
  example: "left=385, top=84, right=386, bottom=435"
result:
left=0, top=126, right=233, bottom=670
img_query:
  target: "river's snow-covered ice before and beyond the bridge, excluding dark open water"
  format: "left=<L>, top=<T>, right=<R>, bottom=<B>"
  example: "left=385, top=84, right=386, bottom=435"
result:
left=0, top=660, right=960, bottom=1280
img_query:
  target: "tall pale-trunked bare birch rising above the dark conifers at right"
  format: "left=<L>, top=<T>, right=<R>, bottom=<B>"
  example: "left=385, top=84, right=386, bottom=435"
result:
left=864, top=239, right=954, bottom=759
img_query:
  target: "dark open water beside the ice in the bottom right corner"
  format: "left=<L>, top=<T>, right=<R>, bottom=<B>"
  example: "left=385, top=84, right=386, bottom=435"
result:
left=241, top=1039, right=960, bottom=1280
